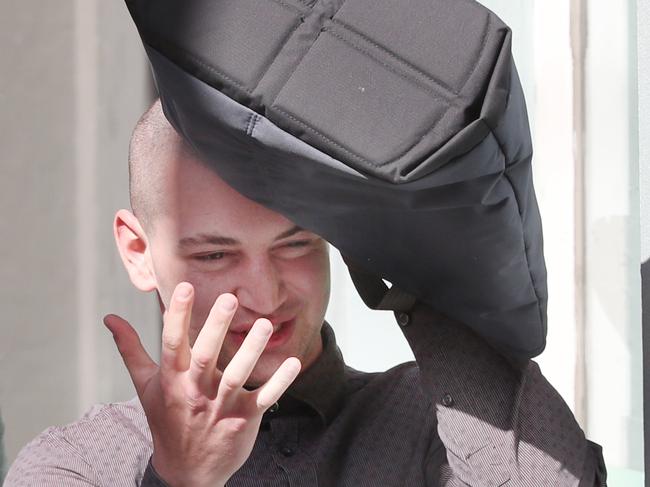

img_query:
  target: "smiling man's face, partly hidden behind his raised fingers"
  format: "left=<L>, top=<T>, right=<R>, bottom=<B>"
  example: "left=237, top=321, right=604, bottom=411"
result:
left=148, top=157, right=329, bottom=385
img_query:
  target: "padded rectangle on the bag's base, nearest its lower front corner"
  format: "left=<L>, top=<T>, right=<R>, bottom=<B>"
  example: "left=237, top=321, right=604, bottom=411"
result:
left=274, top=30, right=447, bottom=170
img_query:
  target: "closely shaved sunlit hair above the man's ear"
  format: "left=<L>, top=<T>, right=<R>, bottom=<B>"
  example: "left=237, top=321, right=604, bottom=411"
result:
left=129, top=99, right=193, bottom=231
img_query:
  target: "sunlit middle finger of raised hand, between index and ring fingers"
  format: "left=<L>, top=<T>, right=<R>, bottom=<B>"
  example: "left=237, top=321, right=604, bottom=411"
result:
left=190, top=294, right=237, bottom=395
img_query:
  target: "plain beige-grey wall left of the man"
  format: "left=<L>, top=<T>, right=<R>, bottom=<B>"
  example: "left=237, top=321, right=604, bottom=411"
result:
left=0, top=0, right=158, bottom=461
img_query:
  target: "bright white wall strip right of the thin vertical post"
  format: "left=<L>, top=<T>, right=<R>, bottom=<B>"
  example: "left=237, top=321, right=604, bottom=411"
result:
left=585, top=0, right=643, bottom=471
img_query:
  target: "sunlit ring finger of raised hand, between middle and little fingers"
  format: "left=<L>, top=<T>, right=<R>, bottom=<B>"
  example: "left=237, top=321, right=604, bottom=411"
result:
left=219, top=318, right=273, bottom=394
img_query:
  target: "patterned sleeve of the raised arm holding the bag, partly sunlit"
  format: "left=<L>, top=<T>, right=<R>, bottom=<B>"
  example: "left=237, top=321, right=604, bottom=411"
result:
left=398, top=305, right=606, bottom=487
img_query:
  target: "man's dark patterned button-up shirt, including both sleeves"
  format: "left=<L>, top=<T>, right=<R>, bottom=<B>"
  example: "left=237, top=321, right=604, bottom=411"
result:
left=6, top=306, right=605, bottom=487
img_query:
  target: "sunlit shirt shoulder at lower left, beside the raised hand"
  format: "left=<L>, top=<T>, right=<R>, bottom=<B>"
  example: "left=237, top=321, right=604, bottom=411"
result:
left=6, top=399, right=152, bottom=486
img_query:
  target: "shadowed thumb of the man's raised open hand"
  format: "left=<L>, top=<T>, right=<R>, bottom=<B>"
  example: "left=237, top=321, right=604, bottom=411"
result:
left=104, top=315, right=158, bottom=397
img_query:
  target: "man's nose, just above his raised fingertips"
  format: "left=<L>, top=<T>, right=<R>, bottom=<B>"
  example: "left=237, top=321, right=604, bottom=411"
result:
left=234, top=257, right=287, bottom=316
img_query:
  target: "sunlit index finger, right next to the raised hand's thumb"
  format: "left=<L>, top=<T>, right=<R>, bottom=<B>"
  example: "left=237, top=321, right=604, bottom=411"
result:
left=160, top=282, right=194, bottom=376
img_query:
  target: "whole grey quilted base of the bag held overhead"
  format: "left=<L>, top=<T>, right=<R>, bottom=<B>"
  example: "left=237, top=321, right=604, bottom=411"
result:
left=131, top=0, right=509, bottom=182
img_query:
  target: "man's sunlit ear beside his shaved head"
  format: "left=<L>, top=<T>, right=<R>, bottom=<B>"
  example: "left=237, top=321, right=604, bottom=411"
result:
left=113, top=210, right=157, bottom=292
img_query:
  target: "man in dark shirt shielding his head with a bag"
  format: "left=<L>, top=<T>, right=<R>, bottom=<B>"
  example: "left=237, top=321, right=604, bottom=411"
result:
left=6, top=103, right=605, bottom=487
